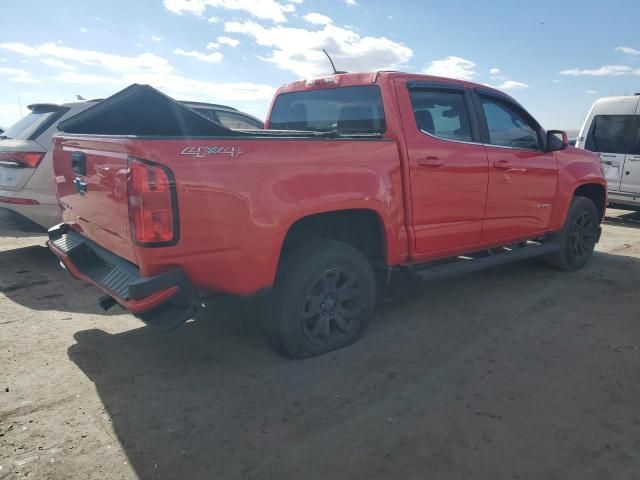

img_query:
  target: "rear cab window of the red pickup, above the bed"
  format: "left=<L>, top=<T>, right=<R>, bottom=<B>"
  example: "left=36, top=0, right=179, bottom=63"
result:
left=269, top=85, right=387, bottom=133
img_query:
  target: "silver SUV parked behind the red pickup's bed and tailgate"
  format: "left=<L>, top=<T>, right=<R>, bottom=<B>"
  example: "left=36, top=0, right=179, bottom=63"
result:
left=0, top=100, right=264, bottom=231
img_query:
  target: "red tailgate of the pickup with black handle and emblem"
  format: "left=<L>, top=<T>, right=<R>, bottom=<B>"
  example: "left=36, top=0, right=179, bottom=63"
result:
left=53, top=137, right=136, bottom=263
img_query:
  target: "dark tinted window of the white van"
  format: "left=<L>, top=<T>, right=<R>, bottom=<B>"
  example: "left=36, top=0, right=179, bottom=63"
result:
left=584, top=115, right=640, bottom=154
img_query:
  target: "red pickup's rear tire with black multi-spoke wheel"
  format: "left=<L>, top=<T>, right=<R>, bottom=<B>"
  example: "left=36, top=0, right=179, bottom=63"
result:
left=269, top=239, right=376, bottom=358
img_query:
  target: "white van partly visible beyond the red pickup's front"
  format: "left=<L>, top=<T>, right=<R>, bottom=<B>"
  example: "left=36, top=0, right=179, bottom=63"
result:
left=576, top=94, right=640, bottom=208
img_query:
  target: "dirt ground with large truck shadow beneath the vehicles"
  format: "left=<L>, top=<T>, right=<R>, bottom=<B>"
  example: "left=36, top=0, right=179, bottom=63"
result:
left=0, top=211, right=640, bottom=480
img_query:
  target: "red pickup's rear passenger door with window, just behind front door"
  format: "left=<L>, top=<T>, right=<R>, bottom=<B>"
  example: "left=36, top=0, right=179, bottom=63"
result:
left=398, top=82, right=488, bottom=259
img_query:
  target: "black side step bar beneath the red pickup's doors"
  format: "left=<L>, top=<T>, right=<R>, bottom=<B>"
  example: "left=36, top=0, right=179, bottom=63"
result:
left=407, top=242, right=560, bottom=280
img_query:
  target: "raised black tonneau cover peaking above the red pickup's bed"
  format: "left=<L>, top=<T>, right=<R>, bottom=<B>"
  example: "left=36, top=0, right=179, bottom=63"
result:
left=58, top=83, right=239, bottom=137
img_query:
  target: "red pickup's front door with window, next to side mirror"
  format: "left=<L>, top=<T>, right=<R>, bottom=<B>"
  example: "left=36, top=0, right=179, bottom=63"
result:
left=478, top=94, right=558, bottom=244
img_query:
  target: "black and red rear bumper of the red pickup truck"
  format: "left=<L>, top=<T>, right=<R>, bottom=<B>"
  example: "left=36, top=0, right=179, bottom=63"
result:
left=48, top=224, right=196, bottom=318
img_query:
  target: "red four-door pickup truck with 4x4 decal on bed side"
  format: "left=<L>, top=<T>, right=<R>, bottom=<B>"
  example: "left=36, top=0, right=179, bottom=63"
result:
left=49, top=72, right=607, bottom=358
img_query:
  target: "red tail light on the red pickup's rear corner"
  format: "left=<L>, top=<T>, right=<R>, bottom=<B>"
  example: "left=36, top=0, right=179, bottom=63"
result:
left=127, top=158, right=179, bottom=247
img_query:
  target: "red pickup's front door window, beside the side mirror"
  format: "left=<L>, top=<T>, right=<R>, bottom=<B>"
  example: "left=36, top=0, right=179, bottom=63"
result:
left=480, top=97, right=540, bottom=150
